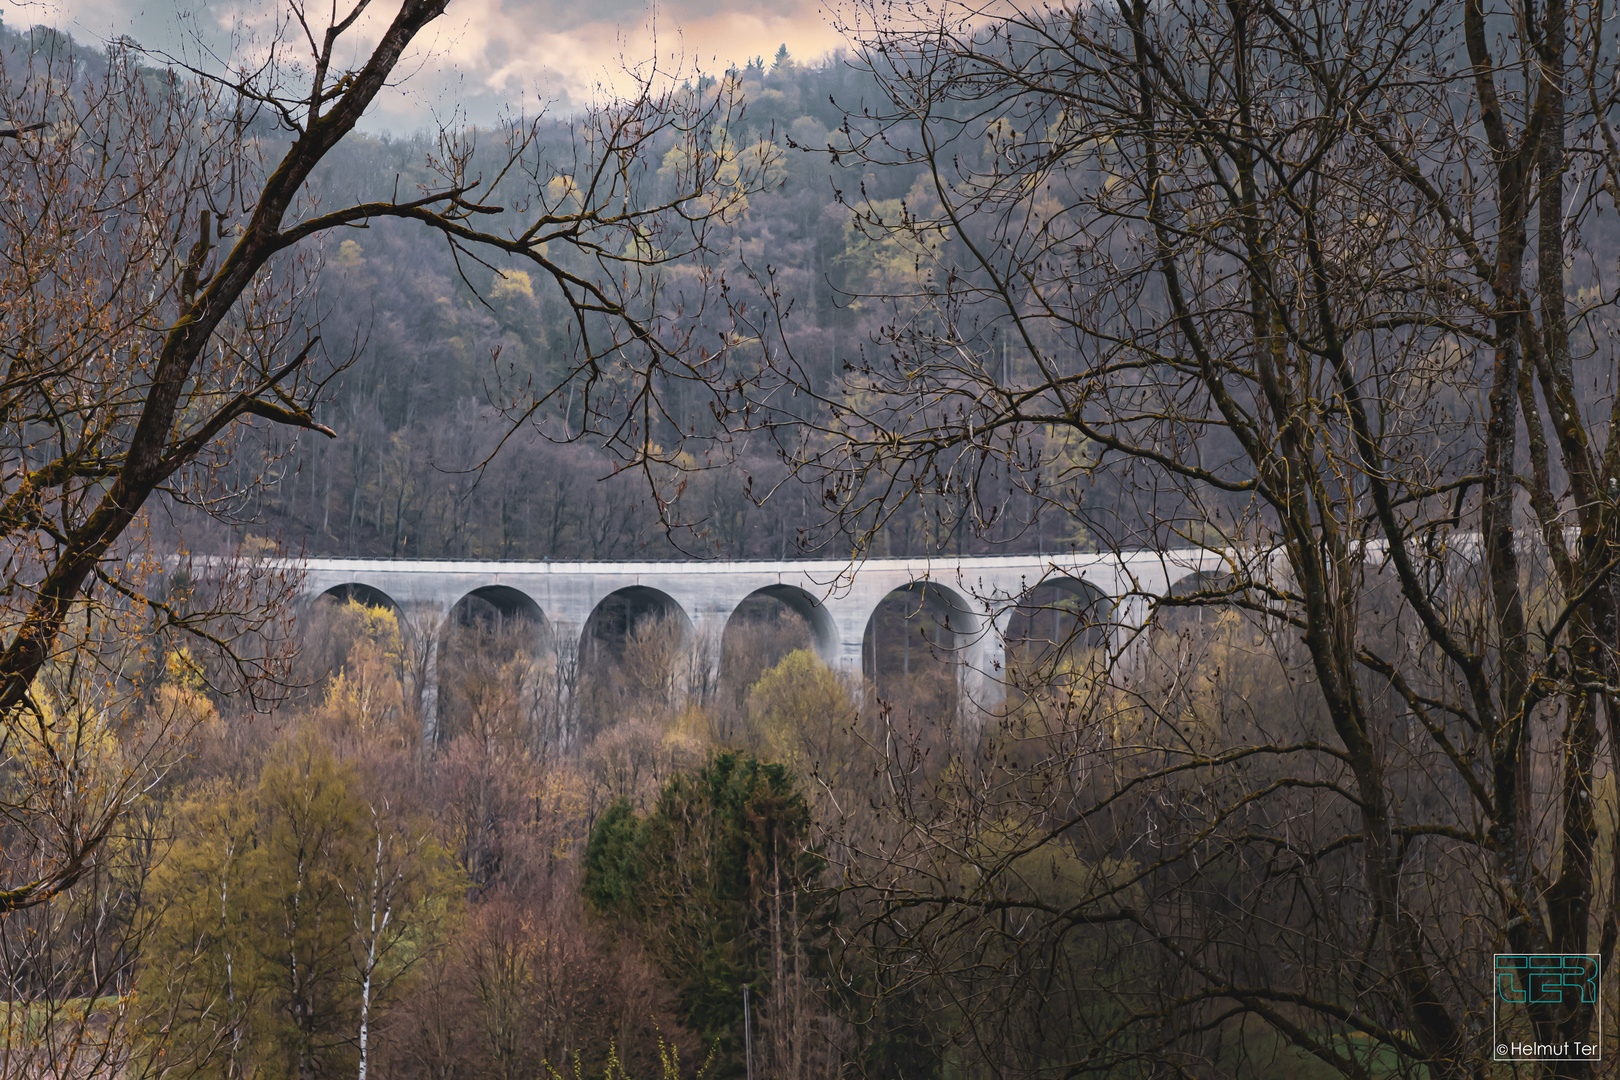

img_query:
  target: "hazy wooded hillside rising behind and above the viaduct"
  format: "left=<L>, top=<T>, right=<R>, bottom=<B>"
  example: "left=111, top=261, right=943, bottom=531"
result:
left=231, top=35, right=1620, bottom=560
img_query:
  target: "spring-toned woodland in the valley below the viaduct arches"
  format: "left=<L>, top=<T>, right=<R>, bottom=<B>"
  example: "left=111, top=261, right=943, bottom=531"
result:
left=82, top=579, right=1140, bottom=1080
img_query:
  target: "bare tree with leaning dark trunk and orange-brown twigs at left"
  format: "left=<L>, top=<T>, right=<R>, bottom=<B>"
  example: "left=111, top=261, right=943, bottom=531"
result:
left=0, top=0, right=750, bottom=932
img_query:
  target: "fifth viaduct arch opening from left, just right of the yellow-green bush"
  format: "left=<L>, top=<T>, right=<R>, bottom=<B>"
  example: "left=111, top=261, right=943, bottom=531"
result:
left=860, top=581, right=978, bottom=719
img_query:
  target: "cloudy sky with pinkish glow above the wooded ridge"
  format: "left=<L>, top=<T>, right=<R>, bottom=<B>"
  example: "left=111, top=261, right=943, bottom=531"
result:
left=15, top=0, right=839, bottom=131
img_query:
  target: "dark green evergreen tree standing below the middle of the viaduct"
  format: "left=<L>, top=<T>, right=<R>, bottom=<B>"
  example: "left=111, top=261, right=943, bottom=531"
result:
left=583, top=753, right=829, bottom=1077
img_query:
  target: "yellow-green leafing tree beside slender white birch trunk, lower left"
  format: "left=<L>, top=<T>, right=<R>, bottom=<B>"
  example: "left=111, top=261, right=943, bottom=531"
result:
left=138, top=732, right=455, bottom=1080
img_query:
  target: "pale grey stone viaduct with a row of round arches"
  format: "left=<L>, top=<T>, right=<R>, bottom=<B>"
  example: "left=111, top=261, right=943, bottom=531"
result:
left=303, top=551, right=1223, bottom=737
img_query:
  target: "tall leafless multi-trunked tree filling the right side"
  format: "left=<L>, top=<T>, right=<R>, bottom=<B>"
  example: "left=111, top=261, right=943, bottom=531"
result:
left=719, top=0, right=1620, bottom=1077
